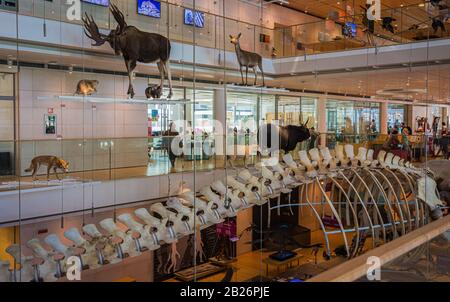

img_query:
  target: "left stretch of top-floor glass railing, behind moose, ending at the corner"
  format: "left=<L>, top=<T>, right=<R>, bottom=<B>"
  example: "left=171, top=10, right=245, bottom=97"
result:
left=9, top=0, right=273, bottom=57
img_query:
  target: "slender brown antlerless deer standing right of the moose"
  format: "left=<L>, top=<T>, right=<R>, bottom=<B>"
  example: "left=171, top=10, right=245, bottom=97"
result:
left=230, top=33, right=266, bottom=86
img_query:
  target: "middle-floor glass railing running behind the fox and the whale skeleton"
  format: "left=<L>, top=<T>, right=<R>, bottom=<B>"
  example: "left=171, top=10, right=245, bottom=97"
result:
left=0, top=132, right=442, bottom=189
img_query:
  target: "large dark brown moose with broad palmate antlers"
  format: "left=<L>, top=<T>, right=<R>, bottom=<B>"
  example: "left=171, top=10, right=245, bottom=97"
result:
left=83, top=4, right=173, bottom=99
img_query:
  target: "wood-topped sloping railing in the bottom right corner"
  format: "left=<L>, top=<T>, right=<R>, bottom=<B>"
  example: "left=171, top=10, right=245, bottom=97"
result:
left=308, top=216, right=450, bottom=282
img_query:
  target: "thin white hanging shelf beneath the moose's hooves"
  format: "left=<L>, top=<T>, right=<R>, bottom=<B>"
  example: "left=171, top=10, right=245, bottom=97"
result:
left=37, top=95, right=191, bottom=105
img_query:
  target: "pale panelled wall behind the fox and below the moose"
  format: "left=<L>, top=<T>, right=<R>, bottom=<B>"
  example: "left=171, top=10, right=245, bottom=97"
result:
left=18, top=68, right=148, bottom=172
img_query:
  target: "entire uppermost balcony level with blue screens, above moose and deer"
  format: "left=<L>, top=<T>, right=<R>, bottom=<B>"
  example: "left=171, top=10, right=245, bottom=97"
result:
left=0, top=0, right=449, bottom=58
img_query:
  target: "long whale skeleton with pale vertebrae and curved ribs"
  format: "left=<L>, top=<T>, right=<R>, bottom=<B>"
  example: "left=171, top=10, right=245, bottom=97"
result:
left=7, top=144, right=445, bottom=281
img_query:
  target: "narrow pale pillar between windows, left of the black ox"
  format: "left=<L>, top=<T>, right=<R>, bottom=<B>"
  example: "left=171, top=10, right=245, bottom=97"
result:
left=213, top=87, right=227, bottom=159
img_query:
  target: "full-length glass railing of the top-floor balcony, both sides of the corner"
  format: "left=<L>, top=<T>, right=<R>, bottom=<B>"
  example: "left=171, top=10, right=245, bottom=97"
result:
left=0, top=0, right=447, bottom=58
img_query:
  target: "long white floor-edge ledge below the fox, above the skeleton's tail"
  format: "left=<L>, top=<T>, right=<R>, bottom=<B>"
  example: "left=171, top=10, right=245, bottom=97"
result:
left=0, top=169, right=226, bottom=224
